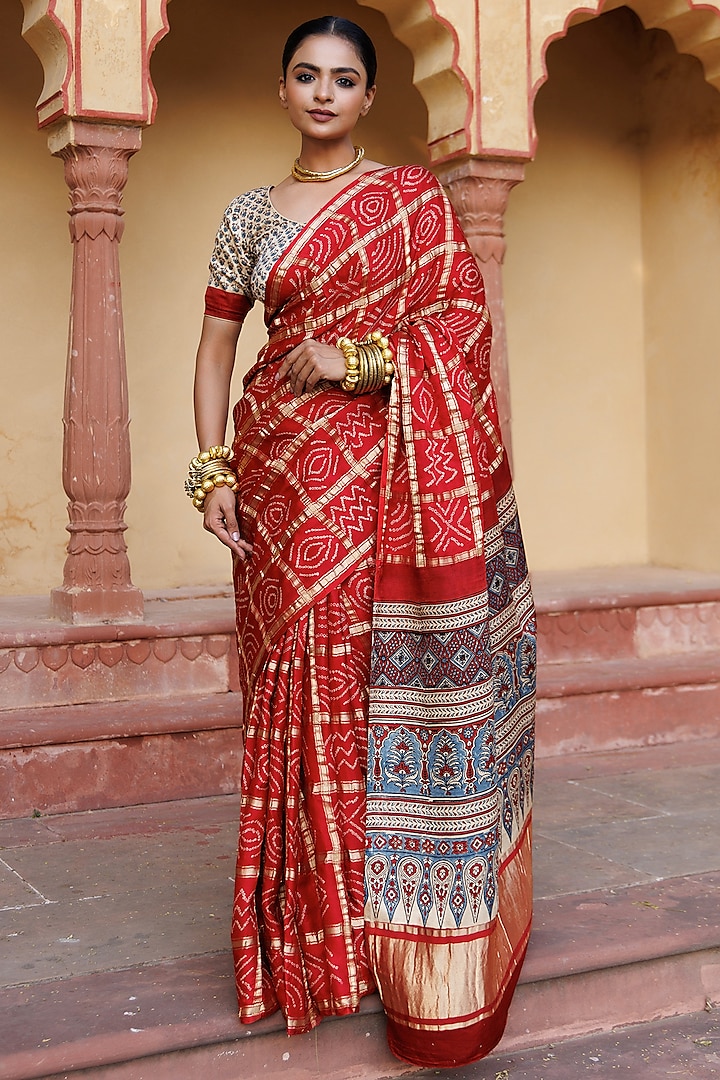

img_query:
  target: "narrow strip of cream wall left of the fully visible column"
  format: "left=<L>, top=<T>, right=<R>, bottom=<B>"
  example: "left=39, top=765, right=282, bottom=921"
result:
left=0, top=3, right=71, bottom=593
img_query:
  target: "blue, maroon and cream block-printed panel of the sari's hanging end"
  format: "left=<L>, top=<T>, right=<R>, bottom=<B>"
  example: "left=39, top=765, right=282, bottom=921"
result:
left=366, top=507, right=535, bottom=927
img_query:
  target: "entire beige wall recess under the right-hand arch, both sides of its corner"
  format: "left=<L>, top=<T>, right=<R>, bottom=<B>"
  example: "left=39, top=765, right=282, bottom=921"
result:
left=505, top=9, right=720, bottom=570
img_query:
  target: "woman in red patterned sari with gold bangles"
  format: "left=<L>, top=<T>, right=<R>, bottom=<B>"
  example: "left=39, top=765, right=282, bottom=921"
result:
left=189, top=16, right=534, bottom=1066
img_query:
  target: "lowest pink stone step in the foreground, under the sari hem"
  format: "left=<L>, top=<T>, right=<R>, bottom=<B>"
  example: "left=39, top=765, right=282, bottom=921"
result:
left=0, top=873, right=720, bottom=1080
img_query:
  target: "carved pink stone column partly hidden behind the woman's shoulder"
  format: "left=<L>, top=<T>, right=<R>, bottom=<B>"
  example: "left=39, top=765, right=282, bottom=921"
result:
left=437, top=158, right=525, bottom=460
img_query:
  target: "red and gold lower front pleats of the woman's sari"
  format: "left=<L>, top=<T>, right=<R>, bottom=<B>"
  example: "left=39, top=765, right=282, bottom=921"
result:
left=232, top=566, right=372, bottom=1031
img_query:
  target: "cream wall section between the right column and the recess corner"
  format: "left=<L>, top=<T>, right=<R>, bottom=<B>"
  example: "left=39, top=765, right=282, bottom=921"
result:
left=505, top=12, right=649, bottom=569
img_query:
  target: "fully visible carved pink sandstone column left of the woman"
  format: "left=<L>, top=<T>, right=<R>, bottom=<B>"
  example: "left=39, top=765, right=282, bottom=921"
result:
left=51, top=122, right=142, bottom=623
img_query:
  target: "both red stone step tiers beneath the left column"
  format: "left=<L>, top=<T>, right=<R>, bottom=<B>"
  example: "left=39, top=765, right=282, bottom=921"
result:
left=0, top=589, right=242, bottom=819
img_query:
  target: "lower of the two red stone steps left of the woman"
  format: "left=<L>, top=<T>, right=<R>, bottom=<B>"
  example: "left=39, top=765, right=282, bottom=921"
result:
left=0, top=691, right=242, bottom=819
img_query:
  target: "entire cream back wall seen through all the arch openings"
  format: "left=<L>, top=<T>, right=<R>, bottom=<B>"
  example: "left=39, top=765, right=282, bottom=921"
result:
left=5, top=0, right=720, bottom=593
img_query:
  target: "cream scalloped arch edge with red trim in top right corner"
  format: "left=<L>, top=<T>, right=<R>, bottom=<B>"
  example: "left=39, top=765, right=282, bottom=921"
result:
left=529, top=0, right=720, bottom=123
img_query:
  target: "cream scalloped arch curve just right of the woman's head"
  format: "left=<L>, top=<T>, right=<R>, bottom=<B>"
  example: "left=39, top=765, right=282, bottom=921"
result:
left=357, top=0, right=474, bottom=163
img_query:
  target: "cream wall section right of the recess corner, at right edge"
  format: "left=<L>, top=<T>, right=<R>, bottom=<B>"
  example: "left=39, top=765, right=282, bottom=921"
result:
left=643, top=35, right=720, bottom=570
